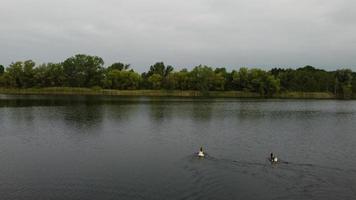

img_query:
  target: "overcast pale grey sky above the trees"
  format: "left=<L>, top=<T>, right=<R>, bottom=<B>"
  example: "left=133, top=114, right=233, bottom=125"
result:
left=0, top=0, right=356, bottom=71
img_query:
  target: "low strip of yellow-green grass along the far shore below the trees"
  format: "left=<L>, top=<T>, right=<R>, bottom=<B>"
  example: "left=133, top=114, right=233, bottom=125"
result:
left=0, top=87, right=342, bottom=99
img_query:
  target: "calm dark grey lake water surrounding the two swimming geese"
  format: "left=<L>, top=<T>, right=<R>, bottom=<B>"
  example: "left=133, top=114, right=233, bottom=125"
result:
left=0, top=95, right=356, bottom=200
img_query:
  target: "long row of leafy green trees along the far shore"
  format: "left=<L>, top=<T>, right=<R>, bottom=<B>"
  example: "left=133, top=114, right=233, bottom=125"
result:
left=0, top=54, right=356, bottom=98
